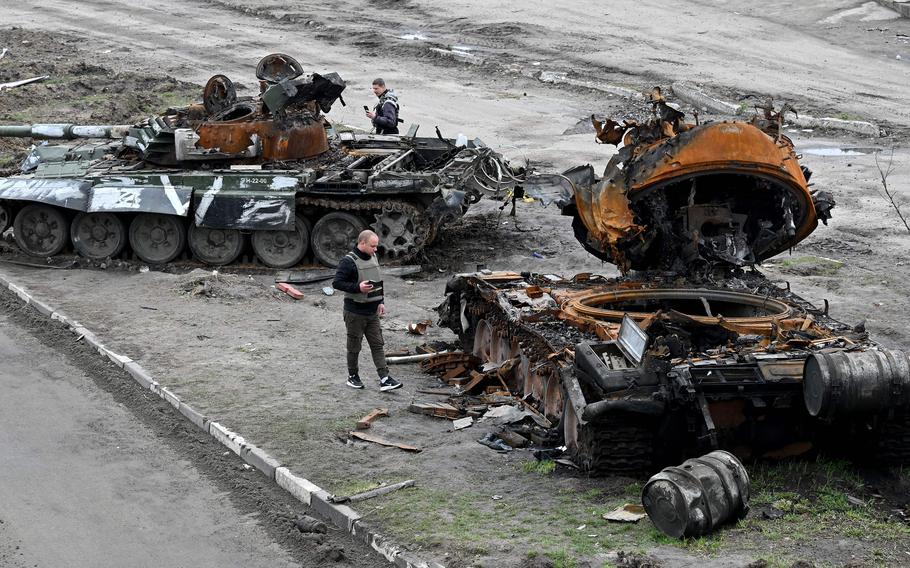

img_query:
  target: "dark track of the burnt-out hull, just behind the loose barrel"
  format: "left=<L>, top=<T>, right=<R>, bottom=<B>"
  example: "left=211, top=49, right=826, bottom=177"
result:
left=572, top=413, right=657, bottom=477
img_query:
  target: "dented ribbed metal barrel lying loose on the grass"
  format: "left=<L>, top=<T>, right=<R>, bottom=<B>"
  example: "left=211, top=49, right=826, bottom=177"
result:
left=641, top=450, right=750, bottom=538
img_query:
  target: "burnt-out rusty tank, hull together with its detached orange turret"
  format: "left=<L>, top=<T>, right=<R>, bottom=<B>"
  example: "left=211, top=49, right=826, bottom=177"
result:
left=439, top=91, right=910, bottom=474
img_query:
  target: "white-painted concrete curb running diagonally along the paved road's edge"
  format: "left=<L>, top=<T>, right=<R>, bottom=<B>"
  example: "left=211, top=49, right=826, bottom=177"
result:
left=0, top=273, right=445, bottom=568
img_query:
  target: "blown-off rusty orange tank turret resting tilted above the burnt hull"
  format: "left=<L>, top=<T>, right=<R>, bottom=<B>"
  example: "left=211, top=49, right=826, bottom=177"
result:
left=529, top=89, right=834, bottom=272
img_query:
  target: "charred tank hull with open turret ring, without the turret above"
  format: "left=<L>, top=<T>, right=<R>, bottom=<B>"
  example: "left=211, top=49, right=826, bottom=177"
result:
left=440, top=273, right=910, bottom=475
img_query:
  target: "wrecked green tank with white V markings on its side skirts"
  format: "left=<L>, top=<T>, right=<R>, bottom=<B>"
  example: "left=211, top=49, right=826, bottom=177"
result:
left=0, top=54, right=515, bottom=268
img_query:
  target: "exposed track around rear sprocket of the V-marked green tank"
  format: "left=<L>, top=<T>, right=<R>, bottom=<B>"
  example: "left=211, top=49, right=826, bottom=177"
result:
left=297, top=196, right=436, bottom=262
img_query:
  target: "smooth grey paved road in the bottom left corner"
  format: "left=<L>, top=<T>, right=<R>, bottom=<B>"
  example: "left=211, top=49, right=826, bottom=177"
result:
left=0, top=314, right=296, bottom=568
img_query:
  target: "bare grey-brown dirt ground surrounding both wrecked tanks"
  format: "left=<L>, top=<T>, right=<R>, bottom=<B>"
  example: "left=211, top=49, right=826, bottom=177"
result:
left=0, top=0, right=910, bottom=567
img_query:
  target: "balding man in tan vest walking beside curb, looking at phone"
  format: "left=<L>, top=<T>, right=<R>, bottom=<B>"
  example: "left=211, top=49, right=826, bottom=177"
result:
left=332, top=230, right=401, bottom=391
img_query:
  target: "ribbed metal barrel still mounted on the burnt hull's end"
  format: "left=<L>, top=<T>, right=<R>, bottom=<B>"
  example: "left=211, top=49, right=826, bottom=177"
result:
left=803, top=349, right=910, bottom=418
